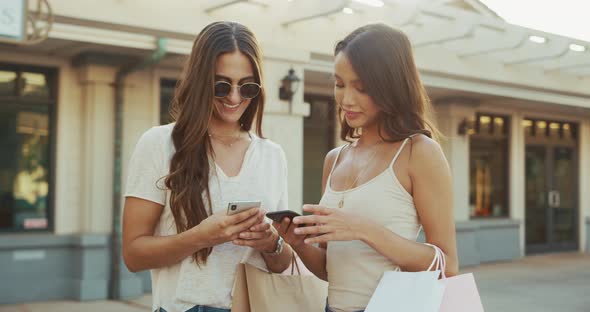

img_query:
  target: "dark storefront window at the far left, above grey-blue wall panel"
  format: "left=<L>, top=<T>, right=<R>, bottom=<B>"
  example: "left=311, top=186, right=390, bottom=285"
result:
left=0, top=65, right=55, bottom=232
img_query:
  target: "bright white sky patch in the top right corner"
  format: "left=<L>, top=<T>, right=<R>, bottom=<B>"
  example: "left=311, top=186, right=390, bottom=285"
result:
left=480, top=0, right=590, bottom=42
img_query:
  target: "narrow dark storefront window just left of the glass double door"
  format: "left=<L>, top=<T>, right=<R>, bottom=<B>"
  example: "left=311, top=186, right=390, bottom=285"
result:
left=469, top=114, right=509, bottom=218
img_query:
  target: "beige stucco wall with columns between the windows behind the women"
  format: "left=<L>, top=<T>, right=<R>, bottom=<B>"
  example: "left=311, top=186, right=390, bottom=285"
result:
left=0, top=36, right=590, bottom=250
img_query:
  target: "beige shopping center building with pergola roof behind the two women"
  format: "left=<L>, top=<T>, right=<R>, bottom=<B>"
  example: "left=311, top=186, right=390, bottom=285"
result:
left=0, top=0, right=590, bottom=303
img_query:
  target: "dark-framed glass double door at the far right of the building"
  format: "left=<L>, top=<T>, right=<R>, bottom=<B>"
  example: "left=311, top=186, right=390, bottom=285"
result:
left=525, top=120, right=578, bottom=253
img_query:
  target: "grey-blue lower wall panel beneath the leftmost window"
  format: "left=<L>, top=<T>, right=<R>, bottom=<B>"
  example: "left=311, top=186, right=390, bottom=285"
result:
left=0, top=234, right=110, bottom=304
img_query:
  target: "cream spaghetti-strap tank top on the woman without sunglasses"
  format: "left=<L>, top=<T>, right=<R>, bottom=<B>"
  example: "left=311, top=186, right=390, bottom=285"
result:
left=320, top=138, right=420, bottom=312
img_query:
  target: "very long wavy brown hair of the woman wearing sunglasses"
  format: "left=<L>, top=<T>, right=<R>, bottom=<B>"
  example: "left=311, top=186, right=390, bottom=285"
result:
left=165, top=22, right=264, bottom=264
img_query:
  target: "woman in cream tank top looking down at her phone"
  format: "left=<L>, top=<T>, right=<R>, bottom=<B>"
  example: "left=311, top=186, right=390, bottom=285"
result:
left=275, top=24, right=458, bottom=311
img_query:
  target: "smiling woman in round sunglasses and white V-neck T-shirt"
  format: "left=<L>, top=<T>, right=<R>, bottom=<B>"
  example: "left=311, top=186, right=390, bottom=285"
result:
left=123, top=22, right=292, bottom=312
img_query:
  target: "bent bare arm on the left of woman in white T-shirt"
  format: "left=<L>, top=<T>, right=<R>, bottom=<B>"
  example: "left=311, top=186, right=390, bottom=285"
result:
left=123, top=197, right=261, bottom=272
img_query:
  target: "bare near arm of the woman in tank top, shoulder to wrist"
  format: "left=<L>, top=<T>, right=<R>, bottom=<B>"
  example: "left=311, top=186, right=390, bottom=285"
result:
left=361, top=136, right=458, bottom=276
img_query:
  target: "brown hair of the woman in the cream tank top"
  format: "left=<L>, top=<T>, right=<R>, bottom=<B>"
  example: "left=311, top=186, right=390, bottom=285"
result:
left=334, top=23, right=440, bottom=142
